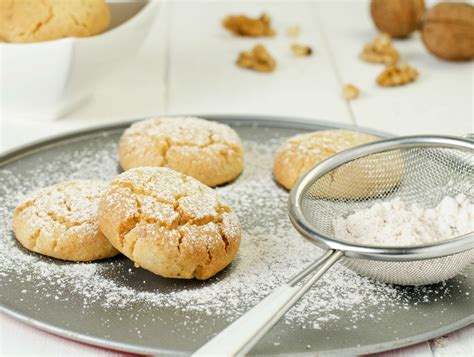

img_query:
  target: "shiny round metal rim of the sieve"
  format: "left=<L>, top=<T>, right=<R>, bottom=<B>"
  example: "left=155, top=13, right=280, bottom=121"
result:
left=288, top=135, right=474, bottom=261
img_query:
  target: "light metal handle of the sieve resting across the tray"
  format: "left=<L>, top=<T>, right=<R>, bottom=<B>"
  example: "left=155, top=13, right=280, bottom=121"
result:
left=193, top=250, right=343, bottom=356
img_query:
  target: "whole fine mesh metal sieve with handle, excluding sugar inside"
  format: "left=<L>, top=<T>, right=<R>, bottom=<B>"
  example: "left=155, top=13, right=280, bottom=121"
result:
left=195, top=136, right=474, bottom=355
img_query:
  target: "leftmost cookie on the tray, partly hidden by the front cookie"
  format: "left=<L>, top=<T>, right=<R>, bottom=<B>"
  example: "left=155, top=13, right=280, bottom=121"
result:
left=13, top=180, right=118, bottom=261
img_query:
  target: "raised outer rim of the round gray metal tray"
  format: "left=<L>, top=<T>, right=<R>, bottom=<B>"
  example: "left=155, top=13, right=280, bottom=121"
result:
left=0, top=114, right=474, bottom=355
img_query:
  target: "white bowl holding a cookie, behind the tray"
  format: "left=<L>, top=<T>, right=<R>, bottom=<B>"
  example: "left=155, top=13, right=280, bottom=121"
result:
left=0, top=0, right=158, bottom=120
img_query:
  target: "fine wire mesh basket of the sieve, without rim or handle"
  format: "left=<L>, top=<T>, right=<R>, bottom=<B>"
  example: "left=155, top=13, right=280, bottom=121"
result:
left=300, top=144, right=474, bottom=285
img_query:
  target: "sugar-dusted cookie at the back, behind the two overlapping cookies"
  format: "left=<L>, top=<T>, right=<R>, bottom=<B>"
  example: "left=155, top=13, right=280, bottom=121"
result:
left=119, top=117, right=244, bottom=187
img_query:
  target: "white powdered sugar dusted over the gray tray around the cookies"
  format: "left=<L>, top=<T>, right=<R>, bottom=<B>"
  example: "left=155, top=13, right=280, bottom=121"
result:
left=0, top=131, right=466, bottom=329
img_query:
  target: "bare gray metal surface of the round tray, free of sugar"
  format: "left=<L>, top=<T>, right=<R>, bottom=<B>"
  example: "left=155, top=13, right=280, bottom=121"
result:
left=0, top=116, right=474, bottom=355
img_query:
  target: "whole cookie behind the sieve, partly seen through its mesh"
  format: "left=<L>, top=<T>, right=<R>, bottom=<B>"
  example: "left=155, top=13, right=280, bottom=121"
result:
left=273, top=130, right=405, bottom=200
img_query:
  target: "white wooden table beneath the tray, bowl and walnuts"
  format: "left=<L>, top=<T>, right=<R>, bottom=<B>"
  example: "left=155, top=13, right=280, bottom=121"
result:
left=0, top=0, right=474, bottom=357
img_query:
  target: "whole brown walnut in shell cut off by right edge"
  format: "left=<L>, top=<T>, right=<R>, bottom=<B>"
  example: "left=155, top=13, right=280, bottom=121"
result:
left=421, top=3, right=474, bottom=61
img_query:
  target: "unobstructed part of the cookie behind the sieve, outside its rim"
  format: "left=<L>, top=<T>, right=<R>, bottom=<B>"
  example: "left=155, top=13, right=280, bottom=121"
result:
left=273, top=130, right=379, bottom=190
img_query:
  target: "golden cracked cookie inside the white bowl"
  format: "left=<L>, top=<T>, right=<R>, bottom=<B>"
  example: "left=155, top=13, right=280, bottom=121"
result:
left=0, top=0, right=110, bottom=42
